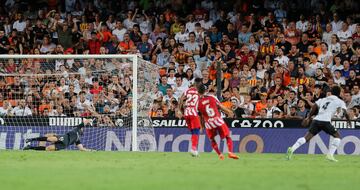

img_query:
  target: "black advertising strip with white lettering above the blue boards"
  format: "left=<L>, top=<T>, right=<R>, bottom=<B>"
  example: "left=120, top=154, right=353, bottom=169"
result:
left=0, top=117, right=360, bottom=129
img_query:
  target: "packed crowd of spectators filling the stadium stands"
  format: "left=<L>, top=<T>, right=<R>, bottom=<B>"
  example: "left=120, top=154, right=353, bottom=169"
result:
left=0, top=0, right=360, bottom=122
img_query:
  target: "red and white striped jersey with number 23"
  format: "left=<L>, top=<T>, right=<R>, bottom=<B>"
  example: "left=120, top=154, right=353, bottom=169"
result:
left=184, top=87, right=199, bottom=117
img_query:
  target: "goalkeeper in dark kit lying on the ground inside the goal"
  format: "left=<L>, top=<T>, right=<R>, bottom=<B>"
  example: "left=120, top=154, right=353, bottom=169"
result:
left=23, top=118, right=92, bottom=151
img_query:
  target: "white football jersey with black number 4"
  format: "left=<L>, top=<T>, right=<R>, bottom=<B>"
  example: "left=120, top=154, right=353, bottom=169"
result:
left=314, top=95, right=346, bottom=122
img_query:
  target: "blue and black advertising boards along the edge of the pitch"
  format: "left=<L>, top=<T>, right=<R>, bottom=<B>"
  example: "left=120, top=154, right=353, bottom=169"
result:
left=0, top=118, right=360, bottom=155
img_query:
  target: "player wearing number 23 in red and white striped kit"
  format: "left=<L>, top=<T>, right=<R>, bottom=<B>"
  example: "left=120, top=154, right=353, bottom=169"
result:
left=180, top=79, right=201, bottom=156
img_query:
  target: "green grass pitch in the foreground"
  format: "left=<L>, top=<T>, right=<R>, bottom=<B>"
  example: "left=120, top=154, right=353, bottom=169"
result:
left=0, top=151, right=360, bottom=190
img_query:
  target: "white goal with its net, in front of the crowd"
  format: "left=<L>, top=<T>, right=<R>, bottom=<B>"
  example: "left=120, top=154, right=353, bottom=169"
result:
left=0, top=55, right=159, bottom=151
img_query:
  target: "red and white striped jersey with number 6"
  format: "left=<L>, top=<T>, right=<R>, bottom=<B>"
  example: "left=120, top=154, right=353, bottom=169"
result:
left=198, top=95, right=225, bottom=129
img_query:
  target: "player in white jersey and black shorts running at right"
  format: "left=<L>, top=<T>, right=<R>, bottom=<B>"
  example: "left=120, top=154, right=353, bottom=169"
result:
left=286, top=86, right=351, bottom=162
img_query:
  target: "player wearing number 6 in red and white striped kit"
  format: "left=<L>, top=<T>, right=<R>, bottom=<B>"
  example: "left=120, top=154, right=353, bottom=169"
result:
left=197, top=85, right=239, bottom=160
